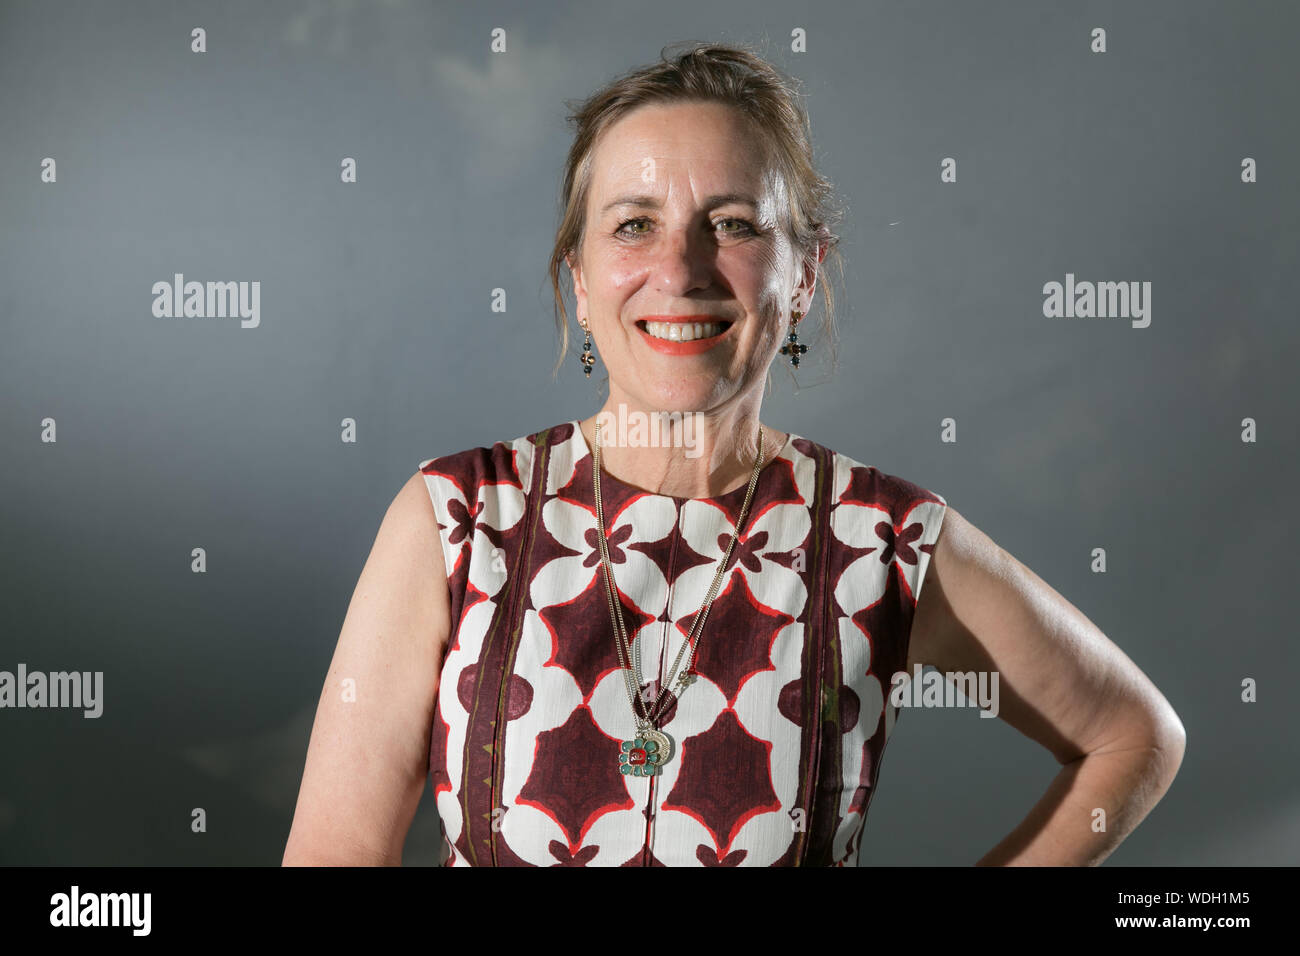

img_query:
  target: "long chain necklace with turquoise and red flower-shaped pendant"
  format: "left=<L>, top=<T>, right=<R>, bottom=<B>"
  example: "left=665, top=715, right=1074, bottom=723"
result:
left=592, top=421, right=763, bottom=777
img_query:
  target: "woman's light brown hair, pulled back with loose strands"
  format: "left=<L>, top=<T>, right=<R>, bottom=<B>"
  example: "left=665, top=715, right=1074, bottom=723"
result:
left=550, top=43, right=844, bottom=378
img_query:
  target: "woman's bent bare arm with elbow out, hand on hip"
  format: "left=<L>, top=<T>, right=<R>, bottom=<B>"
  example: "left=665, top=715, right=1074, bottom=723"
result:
left=906, top=507, right=1187, bottom=866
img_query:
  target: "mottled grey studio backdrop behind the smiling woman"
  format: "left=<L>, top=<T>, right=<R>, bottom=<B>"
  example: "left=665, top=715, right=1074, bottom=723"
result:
left=0, top=0, right=1300, bottom=865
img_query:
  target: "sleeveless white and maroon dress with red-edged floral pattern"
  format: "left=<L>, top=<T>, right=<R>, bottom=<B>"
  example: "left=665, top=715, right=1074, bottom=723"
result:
left=420, top=421, right=946, bottom=866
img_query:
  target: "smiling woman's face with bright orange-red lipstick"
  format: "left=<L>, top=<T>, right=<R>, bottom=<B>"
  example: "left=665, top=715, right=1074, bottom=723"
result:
left=569, top=103, right=816, bottom=411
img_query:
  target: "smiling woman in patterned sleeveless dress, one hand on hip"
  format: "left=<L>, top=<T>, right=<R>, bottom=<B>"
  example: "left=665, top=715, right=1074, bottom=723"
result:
left=285, top=46, right=1184, bottom=866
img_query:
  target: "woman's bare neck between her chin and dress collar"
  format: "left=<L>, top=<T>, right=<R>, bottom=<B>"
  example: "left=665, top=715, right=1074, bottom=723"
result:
left=579, top=397, right=788, bottom=498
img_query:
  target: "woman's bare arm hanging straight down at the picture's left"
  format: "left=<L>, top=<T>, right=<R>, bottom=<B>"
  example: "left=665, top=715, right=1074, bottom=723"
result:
left=283, top=473, right=450, bottom=866
